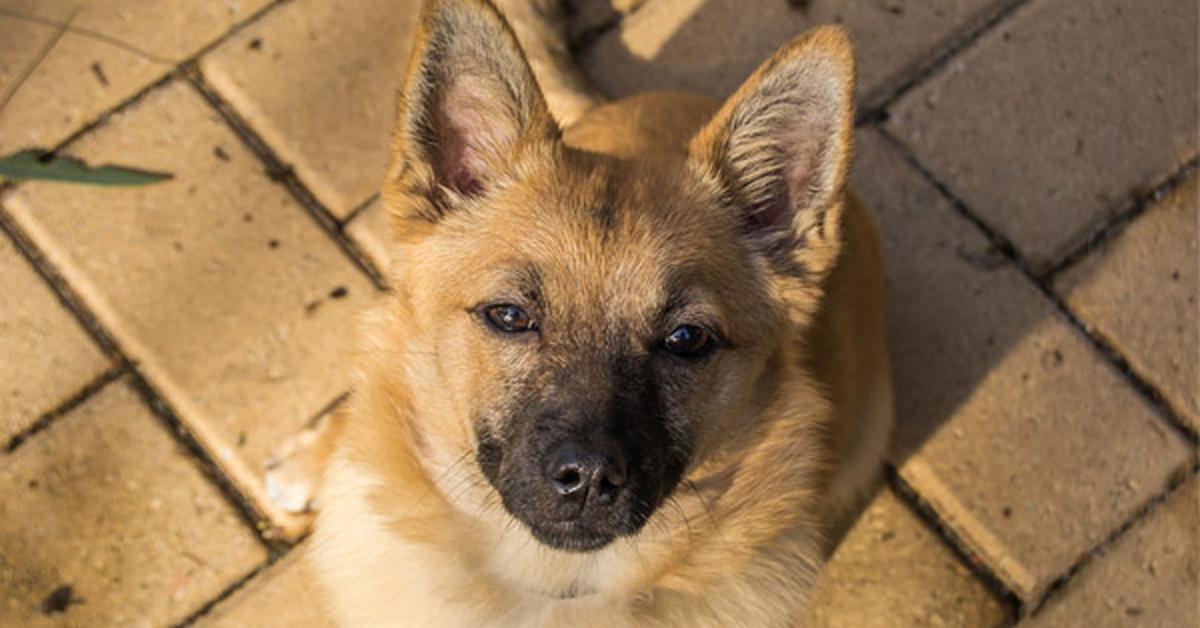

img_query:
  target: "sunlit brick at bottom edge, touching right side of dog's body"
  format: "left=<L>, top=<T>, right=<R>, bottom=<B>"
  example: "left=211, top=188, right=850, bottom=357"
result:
left=805, top=490, right=1008, bottom=628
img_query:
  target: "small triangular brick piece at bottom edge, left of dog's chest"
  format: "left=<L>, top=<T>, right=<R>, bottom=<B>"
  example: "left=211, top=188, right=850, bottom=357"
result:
left=197, top=548, right=336, bottom=628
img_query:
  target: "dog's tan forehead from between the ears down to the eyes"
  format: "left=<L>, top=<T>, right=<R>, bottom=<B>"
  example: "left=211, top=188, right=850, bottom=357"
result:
left=417, top=150, right=766, bottom=330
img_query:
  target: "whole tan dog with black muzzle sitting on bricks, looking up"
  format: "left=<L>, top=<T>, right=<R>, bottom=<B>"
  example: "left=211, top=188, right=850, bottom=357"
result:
left=302, top=0, right=892, bottom=628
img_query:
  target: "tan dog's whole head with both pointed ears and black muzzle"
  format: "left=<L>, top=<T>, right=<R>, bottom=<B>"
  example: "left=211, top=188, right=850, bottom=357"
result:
left=374, top=0, right=853, bottom=551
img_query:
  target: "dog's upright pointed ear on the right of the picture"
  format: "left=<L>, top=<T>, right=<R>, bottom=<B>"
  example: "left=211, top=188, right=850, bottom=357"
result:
left=690, top=26, right=854, bottom=277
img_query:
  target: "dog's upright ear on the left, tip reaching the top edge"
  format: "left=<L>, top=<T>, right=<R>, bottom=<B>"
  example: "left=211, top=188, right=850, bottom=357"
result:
left=385, top=0, right=559, bottom=222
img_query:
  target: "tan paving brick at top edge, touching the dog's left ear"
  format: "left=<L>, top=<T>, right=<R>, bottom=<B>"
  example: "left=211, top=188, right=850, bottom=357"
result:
left=200, top=0, right=419, bottom=217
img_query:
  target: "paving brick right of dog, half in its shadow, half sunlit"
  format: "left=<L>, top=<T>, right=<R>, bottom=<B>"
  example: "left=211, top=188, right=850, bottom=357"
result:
left=854, top=132, right=1190, bottom=602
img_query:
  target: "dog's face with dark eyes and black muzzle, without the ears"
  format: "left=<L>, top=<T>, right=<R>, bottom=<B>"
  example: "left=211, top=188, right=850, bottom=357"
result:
left=398, top=157, right=780, bottom=550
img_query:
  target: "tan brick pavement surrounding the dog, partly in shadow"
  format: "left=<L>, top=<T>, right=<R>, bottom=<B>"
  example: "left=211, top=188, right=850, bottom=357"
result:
left=0, top=0, right=1200, bottom=626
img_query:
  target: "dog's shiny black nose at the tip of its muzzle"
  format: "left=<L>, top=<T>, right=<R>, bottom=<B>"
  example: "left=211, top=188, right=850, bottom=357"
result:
left=547, top=443, right=626, bottom=502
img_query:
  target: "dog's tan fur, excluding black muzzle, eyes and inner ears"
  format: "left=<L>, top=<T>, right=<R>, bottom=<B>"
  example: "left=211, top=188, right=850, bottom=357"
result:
left=312, top=0, right=892, bottom=628
